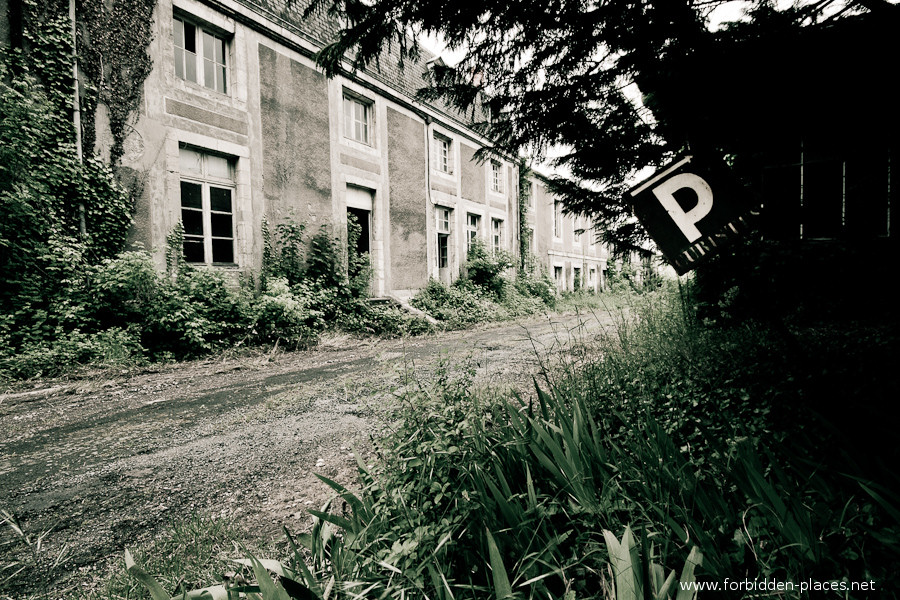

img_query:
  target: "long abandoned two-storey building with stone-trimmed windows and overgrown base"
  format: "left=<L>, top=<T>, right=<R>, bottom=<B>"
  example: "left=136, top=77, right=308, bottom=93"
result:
left=4, top=0, right=607, bottom=298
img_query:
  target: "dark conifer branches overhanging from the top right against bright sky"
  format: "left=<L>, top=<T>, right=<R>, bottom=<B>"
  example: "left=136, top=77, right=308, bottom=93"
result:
left=307, top=0, right=900, bottom=244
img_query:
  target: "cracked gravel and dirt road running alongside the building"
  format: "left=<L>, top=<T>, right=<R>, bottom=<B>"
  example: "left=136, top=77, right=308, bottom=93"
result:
left=0, top=314, right=605, bottom=597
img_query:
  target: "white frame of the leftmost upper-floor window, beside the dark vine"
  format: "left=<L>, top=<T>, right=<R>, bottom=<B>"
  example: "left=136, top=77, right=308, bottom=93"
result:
left=172, top=12, right=231, bottom=95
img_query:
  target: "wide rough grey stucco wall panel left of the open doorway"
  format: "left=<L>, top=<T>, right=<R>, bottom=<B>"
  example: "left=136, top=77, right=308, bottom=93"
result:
left=259, top=44, right=332, bottom=229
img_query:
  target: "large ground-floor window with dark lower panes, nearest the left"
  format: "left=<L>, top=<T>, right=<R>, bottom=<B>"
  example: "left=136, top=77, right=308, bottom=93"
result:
left=178, top=148, right=234, bottom=264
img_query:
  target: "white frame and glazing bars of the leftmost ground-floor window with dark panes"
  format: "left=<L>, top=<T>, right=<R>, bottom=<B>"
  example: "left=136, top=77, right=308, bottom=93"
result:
left=178, top=147, right=237, bottom=265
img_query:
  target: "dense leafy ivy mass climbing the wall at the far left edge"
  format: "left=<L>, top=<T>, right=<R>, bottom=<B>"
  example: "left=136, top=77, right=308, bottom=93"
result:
left=0, top=0, right=141, bottom=352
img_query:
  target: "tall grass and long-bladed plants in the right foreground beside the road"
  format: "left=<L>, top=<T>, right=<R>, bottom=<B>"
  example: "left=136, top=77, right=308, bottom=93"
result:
left=114, top=284, right=900, bottom=600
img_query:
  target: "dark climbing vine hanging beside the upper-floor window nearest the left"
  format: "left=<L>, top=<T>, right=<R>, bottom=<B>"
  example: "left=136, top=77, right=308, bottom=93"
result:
left=76, top=0, right=156, bottom=165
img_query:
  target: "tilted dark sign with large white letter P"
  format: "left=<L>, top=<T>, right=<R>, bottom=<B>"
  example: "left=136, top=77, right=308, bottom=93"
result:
left=628, top=156, right=760, bottom=275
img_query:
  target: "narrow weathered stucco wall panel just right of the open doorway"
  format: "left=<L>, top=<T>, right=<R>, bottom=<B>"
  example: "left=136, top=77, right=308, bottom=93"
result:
left=387, top=108, right=428, bottom=290
